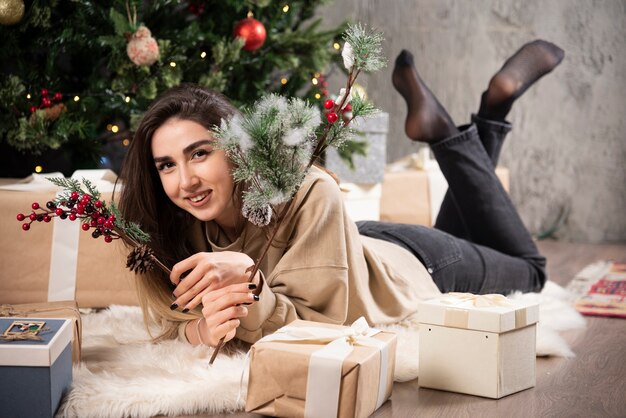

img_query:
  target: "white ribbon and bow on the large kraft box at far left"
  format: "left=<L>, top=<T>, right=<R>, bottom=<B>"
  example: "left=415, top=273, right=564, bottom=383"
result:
left=0, top=170, right=117, bottom=302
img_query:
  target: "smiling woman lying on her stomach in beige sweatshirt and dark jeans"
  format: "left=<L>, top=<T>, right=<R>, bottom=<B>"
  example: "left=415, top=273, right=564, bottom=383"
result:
left=120, top=36, right=563, bottom=352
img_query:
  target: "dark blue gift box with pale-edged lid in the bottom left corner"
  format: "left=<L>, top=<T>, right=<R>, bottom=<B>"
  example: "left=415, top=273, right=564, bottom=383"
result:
left=0, top=318, right=73, bottom=418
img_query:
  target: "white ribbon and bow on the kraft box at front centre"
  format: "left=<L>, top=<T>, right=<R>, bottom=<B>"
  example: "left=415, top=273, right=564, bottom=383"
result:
left=250, top=317, right=389, bottom=418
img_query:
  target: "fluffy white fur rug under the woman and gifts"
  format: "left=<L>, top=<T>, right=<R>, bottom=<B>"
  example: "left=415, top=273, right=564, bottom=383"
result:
left=57, top=282, right=585, bottom=418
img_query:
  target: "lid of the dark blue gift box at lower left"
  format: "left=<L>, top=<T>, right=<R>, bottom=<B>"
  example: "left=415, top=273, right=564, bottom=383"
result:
left=0, top=317, right=73, bottom=367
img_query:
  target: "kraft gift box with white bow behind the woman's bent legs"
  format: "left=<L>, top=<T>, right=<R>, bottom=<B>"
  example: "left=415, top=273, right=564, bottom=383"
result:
left=380, top=152, right=509, bottom=226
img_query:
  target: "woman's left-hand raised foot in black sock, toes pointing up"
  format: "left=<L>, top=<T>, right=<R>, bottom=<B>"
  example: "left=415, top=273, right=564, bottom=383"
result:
left=391, top=49, right=459, bottom=142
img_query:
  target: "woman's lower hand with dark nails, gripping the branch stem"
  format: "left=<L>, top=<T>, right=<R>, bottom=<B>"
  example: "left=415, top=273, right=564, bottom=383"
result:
left=196, top=283, right=259, bottom=347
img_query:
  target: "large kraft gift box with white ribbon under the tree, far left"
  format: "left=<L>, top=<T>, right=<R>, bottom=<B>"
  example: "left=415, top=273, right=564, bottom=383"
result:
left=0, top=170, right=138, bottom=308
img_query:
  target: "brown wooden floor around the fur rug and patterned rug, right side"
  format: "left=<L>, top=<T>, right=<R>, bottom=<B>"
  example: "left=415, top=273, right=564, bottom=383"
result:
left=180, top=241, right=626, bottom=418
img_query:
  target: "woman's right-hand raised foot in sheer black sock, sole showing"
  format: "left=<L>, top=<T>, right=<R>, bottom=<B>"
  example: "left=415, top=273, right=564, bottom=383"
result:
left=478, top=40, right=564, bottom=121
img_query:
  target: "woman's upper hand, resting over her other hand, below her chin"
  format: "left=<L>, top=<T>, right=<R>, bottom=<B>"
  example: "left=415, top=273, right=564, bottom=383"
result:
left=170, top=251, right=260, bottom=312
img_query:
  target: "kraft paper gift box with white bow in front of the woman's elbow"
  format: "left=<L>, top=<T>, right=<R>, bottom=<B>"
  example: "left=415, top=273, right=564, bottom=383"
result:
left=246, top=318, right=397, bottom=417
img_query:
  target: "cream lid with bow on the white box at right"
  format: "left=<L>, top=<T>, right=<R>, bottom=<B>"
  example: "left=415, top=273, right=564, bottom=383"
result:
left=418, top=293, right=539, bottom=333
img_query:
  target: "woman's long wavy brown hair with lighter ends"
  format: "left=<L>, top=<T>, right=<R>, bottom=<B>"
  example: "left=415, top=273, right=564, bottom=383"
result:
left=119, top=84, right=237, bottom=339
